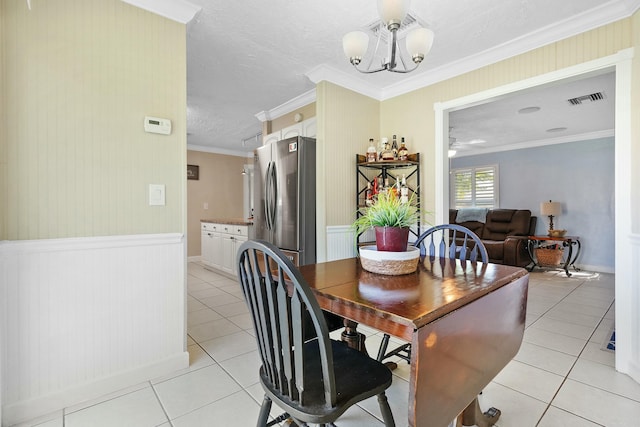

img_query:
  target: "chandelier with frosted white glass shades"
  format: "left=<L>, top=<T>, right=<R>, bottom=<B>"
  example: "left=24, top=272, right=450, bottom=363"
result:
left=342, top=0, right=433, bottom=74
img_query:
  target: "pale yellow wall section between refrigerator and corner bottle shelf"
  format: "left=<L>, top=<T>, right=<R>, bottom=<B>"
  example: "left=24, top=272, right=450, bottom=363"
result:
left=316, top=82, right=380, bottom=229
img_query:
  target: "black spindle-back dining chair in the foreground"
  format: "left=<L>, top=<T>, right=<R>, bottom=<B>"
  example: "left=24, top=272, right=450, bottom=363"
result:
left=237, top=240, right=395, bottom=427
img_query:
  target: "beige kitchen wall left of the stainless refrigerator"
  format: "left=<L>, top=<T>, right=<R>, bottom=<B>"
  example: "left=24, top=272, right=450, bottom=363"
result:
left=187, top=150, right=248, bottom=256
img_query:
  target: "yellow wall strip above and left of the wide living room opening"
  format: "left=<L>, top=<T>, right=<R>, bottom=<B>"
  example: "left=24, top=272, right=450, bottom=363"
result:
left=376, top=19, right=637, bottom=227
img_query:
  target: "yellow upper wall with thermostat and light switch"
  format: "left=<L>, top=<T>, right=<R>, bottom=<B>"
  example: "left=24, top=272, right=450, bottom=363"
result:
left=0, top=0, right=186, bottom=240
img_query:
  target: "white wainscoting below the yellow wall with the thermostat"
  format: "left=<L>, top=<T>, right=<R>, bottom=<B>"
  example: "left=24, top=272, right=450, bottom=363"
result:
left=0, top=233, right=189, bottom=426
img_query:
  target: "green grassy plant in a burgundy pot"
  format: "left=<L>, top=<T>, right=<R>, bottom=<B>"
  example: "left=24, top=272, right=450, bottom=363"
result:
left=353, top=191, right=419, bottom=252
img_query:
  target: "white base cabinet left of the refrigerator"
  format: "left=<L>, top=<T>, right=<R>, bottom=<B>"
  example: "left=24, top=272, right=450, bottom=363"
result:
left=201, top=222, right=250, bottom=276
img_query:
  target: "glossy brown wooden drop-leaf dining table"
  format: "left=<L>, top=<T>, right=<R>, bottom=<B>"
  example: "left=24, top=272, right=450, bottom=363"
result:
left=299, top=258, right=529, bottom=427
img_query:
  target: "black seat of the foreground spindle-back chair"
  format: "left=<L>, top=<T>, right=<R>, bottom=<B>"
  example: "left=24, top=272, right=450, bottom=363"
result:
left=260, top=340, right=392, bottom=424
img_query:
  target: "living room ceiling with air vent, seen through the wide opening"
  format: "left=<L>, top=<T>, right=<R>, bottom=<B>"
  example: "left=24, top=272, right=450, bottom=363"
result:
left=449, top=72, right=615, bottom=156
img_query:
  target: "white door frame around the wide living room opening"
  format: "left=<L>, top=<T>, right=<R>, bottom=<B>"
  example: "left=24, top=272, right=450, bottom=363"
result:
left=434, top=48, right=640, bottom=382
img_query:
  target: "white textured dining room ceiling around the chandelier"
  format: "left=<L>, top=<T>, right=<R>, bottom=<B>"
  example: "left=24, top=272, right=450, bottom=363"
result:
left=182, top=0, right=640, bottom=155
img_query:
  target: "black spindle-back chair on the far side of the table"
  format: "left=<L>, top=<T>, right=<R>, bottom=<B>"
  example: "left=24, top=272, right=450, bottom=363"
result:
left=377, top=224, right=489, bottom=370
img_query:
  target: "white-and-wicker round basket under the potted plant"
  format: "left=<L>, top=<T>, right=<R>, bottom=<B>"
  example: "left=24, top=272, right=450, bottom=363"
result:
left=360, top=246, right=420, bottom=276
